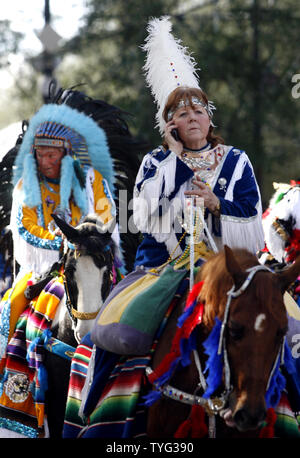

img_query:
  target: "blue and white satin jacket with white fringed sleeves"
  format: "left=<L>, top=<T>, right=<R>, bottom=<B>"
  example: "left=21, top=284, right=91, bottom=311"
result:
left=133, top=141, right=264, bottom=267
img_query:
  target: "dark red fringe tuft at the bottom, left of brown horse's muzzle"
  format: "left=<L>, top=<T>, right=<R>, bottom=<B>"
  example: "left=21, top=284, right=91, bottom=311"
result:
left=174, top=405, right=208, bottom=439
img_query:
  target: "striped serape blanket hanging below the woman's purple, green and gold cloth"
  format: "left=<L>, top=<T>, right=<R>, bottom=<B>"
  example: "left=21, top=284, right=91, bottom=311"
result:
left=63, top=278, right=189, bottom=438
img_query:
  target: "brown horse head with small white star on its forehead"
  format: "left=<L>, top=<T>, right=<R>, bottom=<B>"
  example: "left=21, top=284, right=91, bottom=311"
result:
left=204, top=247, right=300, bottom=431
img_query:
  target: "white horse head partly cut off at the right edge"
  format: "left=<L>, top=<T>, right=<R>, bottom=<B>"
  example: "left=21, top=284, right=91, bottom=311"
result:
left=263, top=183, right=300, bottom=263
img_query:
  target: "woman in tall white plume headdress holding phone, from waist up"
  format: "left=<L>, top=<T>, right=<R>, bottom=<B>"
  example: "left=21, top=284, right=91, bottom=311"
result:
left=134, top=17, right=264, bottom=267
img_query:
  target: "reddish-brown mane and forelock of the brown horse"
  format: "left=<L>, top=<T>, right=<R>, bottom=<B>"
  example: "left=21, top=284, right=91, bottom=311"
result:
left=195, top=248, right=258, bottom=328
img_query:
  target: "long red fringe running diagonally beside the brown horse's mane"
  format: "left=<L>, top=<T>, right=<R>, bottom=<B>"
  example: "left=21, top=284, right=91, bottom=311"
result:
left=148, top=282, right=204, bottom=383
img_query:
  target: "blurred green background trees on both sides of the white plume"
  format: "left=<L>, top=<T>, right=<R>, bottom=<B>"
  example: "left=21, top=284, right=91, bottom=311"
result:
left=2, top=0, right=300, bottom=206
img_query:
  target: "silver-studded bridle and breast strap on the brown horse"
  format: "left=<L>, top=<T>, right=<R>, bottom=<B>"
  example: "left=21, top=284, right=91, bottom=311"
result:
left=146, top=265, right=284, bottom=438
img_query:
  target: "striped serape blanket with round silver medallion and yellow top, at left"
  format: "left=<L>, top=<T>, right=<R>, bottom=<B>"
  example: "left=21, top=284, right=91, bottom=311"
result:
left=0, top=277, right=64, bottom=438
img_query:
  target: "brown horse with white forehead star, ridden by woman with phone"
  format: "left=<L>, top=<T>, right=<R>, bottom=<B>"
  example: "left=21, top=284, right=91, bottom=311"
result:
left=147, top=247, right=300, bottom=438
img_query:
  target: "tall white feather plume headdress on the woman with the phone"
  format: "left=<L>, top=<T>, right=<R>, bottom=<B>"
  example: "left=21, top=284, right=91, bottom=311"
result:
left=142, top=16, right=215, bottom=134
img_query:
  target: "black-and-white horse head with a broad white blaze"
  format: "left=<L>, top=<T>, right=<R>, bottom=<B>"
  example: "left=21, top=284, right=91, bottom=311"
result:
left=52, top=214, right=114, bottom=341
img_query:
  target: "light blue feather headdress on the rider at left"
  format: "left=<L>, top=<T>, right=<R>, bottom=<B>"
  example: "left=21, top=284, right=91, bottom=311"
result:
left=13, top=104, right=115, bottom=214
